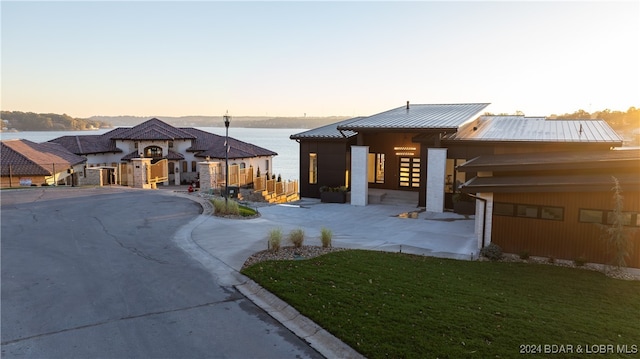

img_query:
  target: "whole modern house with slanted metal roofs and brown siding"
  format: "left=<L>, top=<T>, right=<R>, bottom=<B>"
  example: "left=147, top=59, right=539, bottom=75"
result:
left=290, top=103, right=640, bottom=267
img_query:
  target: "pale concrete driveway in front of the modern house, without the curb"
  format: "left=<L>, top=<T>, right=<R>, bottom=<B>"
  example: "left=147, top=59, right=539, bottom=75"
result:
left=188, top=193, right=478, bottom=285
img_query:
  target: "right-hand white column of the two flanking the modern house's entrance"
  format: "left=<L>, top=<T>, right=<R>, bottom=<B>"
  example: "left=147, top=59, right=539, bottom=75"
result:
left=427, top=148, right=447, bottom=213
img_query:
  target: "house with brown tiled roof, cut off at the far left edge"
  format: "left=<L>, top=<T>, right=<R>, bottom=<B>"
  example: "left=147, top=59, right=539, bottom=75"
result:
left=0, top=140, right=86, bottom=187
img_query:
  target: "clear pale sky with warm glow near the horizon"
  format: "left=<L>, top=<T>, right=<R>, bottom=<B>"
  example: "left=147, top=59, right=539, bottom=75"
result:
left=0, top=1, right=640, bottom=117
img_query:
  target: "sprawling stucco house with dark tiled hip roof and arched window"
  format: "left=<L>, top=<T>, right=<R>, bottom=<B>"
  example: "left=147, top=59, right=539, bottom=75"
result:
left=49, top=118, right=277, bottom=185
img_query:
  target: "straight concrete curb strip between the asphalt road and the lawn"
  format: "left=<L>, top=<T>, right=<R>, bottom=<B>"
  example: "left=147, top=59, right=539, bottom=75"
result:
left=234, top=279, right=365, bottom=359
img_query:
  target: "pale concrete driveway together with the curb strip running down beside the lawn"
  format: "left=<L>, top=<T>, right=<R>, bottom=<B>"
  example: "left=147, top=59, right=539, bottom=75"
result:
left=165, top=189, right=478, bottom=358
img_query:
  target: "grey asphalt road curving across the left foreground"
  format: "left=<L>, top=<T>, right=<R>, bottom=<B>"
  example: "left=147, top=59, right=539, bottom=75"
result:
left=0, top=187, right=321, bottom=358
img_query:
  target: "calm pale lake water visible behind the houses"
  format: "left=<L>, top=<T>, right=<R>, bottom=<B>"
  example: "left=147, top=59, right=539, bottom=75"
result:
left=0, top=127, right=306, bottom=180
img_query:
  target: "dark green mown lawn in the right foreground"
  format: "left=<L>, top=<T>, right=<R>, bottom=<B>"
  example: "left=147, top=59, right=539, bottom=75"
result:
left=243, top=250, right=640, bottom=358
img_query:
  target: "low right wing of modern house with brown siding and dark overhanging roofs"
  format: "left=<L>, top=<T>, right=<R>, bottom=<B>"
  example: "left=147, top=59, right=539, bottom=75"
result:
left=458, top=150, right=640, bottom=268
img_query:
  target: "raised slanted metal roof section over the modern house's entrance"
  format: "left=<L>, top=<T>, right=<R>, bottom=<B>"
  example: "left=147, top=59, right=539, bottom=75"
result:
left=338, top=103, right=489, bottom=131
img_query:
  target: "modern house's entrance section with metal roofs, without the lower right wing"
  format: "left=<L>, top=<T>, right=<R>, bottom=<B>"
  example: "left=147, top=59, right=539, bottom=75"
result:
left=290, top=102, right=622, bottom=211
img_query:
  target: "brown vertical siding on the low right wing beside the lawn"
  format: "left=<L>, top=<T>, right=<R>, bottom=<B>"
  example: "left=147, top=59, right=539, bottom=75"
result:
left=492, top=192, right=640, bottom=268
